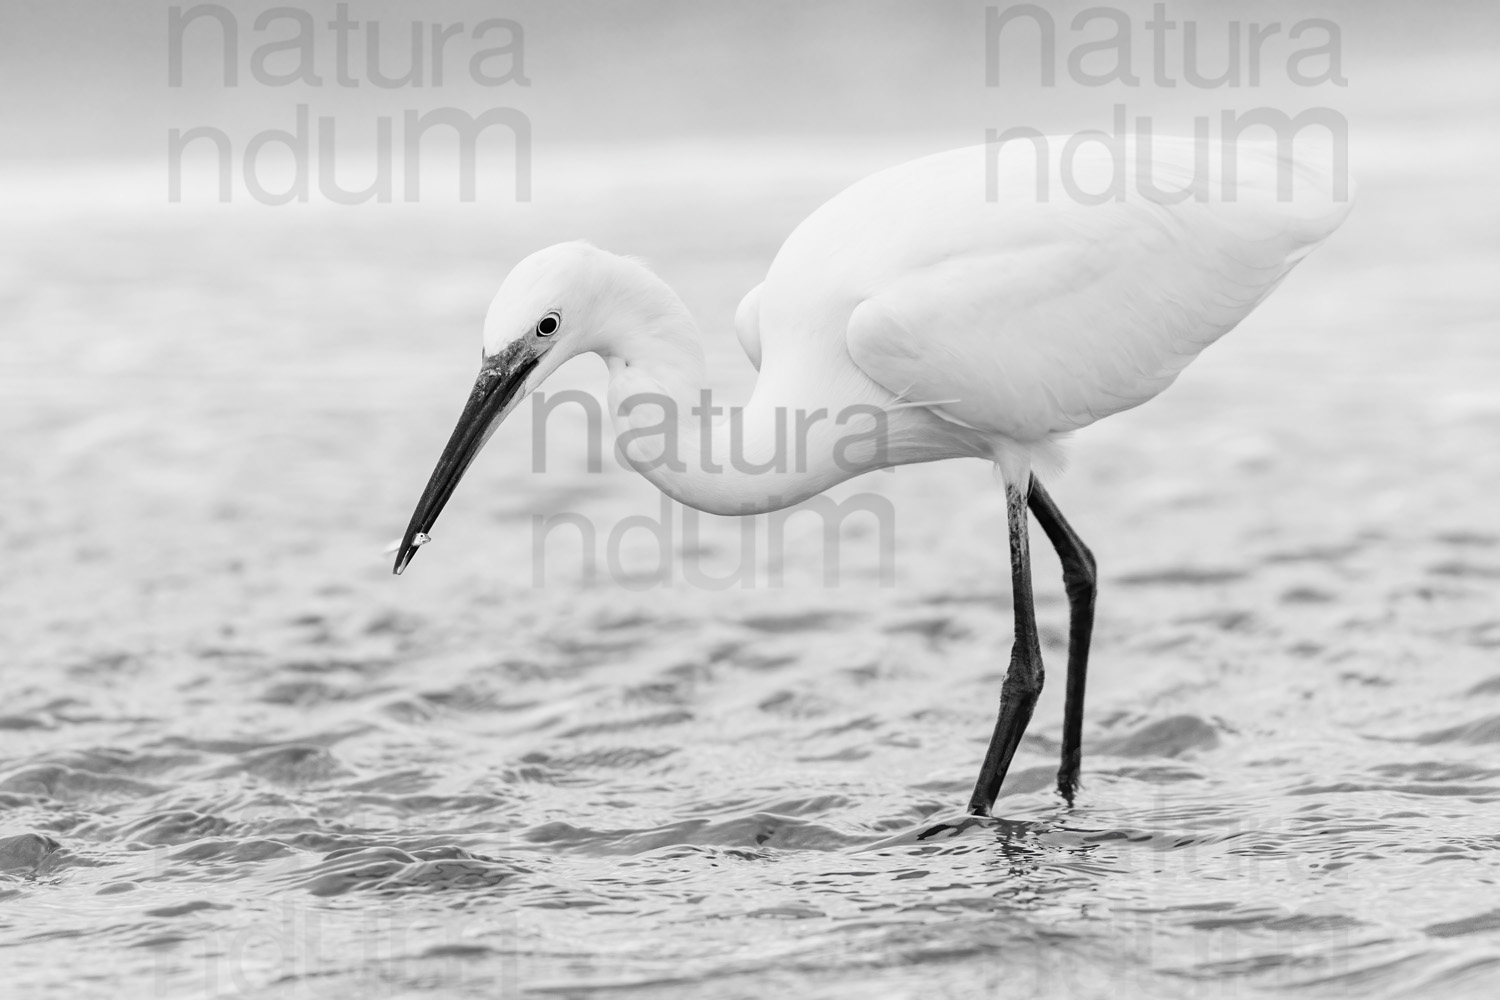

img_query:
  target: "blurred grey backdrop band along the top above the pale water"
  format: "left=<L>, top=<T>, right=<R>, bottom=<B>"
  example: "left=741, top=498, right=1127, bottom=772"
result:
left=0, top=0, right=1500, bottom=165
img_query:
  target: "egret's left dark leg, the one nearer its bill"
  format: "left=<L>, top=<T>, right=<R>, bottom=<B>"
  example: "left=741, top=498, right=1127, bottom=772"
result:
left=969, top=484, right=1043, bottom=816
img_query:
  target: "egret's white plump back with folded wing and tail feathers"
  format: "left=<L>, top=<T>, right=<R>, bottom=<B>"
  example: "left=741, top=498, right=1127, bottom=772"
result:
left=758, top=136, right=1350, bottom=442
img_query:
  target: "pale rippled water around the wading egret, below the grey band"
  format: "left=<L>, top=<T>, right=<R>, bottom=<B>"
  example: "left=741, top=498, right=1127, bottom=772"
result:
left=0, top=127, right=1500, bottom=997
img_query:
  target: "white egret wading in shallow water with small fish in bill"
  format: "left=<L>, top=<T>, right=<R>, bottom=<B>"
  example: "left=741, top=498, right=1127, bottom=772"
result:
left=396, top=135, right=1350, bottom=816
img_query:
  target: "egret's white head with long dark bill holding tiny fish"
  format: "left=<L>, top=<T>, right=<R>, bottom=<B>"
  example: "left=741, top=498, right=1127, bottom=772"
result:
left=396, top=243, right=690, bottom=573
